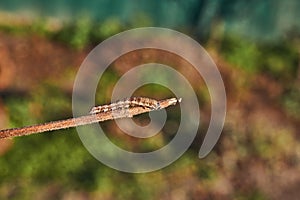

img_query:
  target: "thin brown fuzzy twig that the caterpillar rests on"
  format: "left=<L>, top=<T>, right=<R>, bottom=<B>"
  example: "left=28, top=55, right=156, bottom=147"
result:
left=0, top=98, right=181, bottom=139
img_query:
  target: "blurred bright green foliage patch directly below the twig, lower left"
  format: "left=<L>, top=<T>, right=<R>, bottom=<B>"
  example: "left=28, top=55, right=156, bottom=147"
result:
left=0, top=130, right=103, bottom=190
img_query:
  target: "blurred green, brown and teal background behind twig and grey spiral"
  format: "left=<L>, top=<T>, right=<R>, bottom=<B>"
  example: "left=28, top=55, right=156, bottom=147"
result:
left=0, top=0, right=300, bottom=200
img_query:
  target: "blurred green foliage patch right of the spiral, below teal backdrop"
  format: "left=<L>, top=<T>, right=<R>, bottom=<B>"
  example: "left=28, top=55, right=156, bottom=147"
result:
left=220, top=36, right=298, bottom=81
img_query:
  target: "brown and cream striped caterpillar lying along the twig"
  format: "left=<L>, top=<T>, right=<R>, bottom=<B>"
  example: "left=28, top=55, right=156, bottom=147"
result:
left=89, top=97, right=160, bottom=114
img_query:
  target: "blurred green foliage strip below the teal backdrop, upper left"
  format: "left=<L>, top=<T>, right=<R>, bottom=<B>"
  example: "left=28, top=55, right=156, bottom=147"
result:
left=0, top=15, right=125, bottom=50
